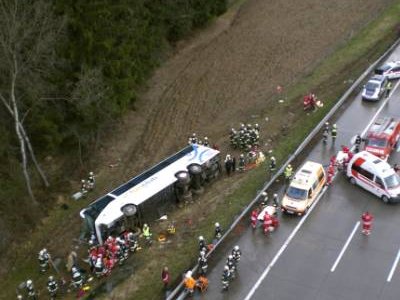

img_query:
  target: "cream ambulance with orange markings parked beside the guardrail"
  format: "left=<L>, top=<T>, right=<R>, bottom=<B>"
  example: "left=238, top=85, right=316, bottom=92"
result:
left=281, top=161, right=326, bottom=216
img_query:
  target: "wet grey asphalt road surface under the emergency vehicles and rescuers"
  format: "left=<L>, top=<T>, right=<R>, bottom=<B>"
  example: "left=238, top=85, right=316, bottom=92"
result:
left=188, top=48, right=400, bottom=300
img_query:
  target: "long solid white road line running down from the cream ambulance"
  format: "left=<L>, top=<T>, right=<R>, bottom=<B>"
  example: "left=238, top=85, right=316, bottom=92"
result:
left=244, top=186, right=327, bottom=300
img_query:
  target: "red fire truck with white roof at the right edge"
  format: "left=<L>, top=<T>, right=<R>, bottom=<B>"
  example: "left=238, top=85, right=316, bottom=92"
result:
left=364, top=117, right=400, bottom=160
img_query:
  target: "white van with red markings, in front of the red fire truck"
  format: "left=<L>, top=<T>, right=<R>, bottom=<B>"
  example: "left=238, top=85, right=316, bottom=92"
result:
left=346, top=151, right=400, bottom=203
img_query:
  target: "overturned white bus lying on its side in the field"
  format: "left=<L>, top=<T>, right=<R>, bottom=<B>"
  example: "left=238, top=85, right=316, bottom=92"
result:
left=80, top=145, right=221, bottom=244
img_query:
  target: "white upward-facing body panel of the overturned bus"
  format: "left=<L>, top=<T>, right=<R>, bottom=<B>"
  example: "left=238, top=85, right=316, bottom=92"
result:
left=91, top=145, right=219, bottom=227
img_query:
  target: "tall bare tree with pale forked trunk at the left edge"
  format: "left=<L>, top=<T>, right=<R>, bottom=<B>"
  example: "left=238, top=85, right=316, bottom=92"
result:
left=0, top=0, right=63, bottom=203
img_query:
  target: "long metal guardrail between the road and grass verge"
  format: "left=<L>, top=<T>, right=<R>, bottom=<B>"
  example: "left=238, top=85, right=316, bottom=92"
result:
left=166, top=39, right=400, bottom=300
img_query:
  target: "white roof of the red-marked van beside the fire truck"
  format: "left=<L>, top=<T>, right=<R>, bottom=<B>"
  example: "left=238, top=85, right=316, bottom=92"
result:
left=350, top=151, right=394, bottom=178
